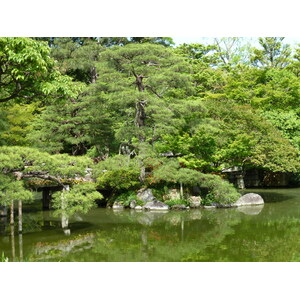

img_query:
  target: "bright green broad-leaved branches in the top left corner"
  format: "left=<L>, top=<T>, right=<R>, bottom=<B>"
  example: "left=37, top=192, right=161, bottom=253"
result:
left=0, top=38, right=83, bottom=102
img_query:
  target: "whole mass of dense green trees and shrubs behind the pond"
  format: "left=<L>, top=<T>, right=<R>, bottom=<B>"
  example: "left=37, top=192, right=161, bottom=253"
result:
left=0, top=37, right=300, bottom=215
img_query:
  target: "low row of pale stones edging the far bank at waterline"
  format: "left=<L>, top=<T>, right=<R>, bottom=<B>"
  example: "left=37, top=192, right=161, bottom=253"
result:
left=112, top=192, right=264, bottom=211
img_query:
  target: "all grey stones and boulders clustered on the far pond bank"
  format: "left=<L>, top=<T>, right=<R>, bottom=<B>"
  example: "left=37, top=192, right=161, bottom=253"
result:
left=113, top=188, right=264, bottom=211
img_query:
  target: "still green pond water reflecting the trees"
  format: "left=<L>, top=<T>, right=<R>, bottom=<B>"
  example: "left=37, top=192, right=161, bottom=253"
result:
left=0, top=188, right=300, bottom=262
